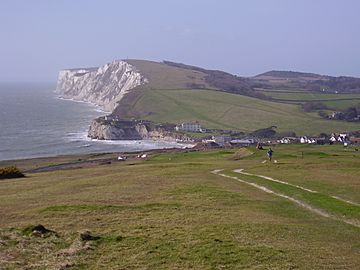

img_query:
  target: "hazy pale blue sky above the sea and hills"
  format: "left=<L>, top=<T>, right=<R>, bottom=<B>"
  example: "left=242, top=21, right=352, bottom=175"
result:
left=0, top=0, right=360, bottom=82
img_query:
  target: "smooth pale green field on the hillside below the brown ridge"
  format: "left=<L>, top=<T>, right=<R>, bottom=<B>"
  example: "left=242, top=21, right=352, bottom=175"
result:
left=121, top=90, right=359, bottom=135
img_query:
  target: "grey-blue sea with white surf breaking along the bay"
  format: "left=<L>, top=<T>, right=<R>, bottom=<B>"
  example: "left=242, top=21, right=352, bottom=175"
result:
left=0, top=84, right=188, bottom=160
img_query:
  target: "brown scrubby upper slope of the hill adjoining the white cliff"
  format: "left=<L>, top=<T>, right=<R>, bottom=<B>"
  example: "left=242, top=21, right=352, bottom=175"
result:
left=113, top=59, right=269, bottom=118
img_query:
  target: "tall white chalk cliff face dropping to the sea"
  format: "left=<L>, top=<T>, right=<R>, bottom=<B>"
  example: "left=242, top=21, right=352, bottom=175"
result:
left=56, top=60, right=148, bottom=111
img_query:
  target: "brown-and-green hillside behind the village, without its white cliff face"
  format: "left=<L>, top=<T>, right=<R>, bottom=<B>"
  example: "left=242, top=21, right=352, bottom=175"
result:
left=109, top=60, right=360, bottom=135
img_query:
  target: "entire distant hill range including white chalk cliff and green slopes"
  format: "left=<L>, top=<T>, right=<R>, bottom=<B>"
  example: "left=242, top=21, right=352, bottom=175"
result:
left=57, top=59, right=360, bottom=135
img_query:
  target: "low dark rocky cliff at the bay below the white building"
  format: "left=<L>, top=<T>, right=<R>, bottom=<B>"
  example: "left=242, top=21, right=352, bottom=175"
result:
left=88, top=117, right=192, bottom=142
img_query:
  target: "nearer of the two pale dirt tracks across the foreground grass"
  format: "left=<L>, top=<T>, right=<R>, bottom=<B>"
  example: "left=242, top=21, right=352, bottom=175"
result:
left=211, top=169, right=360, bottom=228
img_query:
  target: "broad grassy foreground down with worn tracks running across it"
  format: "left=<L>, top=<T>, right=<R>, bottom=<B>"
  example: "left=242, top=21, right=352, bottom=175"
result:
left=0, top=145, right=360, bottom=269
